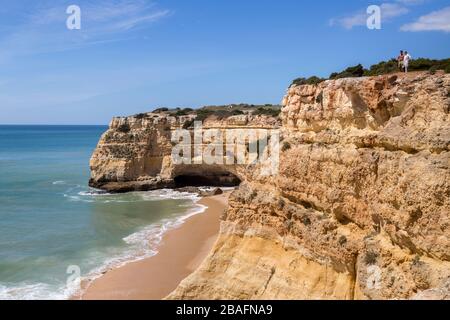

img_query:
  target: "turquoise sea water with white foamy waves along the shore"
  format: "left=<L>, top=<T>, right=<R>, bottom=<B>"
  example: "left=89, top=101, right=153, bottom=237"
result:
left=0, top=126, right=203, bottom=299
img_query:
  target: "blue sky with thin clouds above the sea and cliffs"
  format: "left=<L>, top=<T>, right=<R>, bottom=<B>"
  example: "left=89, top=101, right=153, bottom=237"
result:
left=0, top=0, right=450, bottom=124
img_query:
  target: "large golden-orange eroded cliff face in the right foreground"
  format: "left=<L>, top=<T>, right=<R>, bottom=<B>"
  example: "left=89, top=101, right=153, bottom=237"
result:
left=168, top=73, right=450, bottom=299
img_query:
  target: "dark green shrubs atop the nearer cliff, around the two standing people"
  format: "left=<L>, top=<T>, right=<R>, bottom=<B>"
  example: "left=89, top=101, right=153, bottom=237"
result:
left=291, top=58, right=450, bottom=85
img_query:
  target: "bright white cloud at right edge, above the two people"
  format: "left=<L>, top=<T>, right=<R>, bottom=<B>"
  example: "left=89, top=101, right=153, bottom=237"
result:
left=400, top=7, right=450, bottom=32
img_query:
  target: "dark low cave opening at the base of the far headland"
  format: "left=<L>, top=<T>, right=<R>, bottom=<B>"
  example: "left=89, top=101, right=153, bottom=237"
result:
left=174, top=173, right=241, bottom=188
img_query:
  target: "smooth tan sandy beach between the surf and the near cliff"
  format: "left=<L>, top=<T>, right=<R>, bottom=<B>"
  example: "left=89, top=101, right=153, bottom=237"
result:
left=81, top=192, right=230, bottom=300
